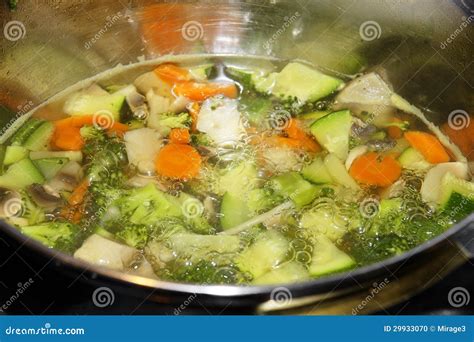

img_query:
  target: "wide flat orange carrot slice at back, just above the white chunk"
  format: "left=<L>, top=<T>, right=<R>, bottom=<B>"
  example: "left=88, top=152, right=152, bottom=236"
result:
left=173, top=81, right=238, bottom=101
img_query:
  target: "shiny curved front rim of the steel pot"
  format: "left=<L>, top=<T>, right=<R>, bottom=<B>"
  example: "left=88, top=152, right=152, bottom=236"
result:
left=0, top=214, right=474, bottom=298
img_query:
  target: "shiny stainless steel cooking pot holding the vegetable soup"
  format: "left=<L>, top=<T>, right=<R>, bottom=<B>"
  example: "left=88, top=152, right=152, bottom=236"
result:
left=0, top=0, right=474, bottom=314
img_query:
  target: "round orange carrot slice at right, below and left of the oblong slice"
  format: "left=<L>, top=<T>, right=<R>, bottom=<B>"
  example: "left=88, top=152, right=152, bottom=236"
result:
left=349, top=152, right=402, bottom=187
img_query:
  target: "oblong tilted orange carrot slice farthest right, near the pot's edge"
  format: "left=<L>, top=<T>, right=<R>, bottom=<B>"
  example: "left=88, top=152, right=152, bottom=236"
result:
left=405, top=131, right=450, bottom=164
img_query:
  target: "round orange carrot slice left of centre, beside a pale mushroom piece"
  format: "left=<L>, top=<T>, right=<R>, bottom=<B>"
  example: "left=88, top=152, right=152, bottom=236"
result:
left=155, top=143, right=201, bottom=180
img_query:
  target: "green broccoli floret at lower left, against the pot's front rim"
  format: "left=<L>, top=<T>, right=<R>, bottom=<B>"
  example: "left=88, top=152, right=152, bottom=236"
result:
left=21, top=222, right=82, bottom=252
